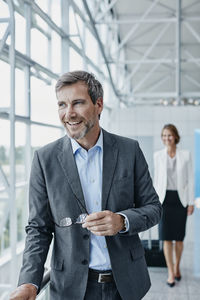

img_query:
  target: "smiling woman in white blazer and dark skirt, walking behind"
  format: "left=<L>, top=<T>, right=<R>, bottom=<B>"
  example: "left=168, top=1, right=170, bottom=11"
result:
left=154, top=124, right=194, bottom=287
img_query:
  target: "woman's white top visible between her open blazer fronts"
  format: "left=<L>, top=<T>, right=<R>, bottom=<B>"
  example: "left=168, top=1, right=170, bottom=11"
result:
left=167, top=155, right=177, bottom=191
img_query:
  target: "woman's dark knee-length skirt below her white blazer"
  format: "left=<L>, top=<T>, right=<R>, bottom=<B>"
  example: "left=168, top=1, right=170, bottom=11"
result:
left=159, top=190, right=187, bottom=241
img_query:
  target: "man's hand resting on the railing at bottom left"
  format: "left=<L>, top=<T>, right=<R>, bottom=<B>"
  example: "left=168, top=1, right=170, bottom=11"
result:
left=9, top=283, right=37, bottom=300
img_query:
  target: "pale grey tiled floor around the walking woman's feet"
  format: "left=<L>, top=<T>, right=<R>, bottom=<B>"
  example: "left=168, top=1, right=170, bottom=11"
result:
left=143, top=240, right=200, bottom=300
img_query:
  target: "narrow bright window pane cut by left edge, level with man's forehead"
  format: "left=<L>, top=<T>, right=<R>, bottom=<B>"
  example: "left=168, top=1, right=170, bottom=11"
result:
left=0, top=60, right=10, bottom=109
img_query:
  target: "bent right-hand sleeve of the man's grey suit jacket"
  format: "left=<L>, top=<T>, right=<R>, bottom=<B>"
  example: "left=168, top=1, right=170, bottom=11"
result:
left=119, top=143, right=162, bottom=235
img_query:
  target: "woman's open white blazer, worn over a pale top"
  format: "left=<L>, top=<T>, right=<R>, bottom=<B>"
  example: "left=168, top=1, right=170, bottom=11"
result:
left=154, top=148, right=194, bottom=207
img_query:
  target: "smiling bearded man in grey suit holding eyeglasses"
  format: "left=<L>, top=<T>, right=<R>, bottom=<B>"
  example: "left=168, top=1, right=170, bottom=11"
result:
left=10, top=71, right=162, bottom=300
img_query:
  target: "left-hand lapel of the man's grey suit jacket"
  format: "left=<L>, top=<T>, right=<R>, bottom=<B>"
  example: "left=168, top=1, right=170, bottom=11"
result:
left=58, top=136, right=87, bottom=213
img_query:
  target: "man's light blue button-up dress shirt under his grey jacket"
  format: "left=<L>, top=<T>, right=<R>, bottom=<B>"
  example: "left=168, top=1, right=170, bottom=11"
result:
left=71, top=130, right=111, bottom=270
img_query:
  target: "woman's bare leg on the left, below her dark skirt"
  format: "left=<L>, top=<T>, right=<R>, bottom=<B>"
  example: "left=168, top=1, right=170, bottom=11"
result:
left=163, top=241, right=174, bottom=283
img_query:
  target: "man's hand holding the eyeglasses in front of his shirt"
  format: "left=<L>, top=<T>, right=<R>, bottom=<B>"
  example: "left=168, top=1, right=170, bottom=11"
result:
left=82, top=210, right=124, bottom=236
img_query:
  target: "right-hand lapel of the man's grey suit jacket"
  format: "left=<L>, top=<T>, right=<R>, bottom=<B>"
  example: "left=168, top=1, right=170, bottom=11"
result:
left=102, top=130, right=118, bottom=210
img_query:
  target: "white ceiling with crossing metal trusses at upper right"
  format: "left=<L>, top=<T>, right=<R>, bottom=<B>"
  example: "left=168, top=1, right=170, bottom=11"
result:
left=110, top=0, right=200, bottom=101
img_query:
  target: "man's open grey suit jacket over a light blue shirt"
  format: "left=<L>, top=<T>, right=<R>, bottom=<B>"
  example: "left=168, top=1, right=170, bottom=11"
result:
left=19, top=130, right=162, bottom=300
